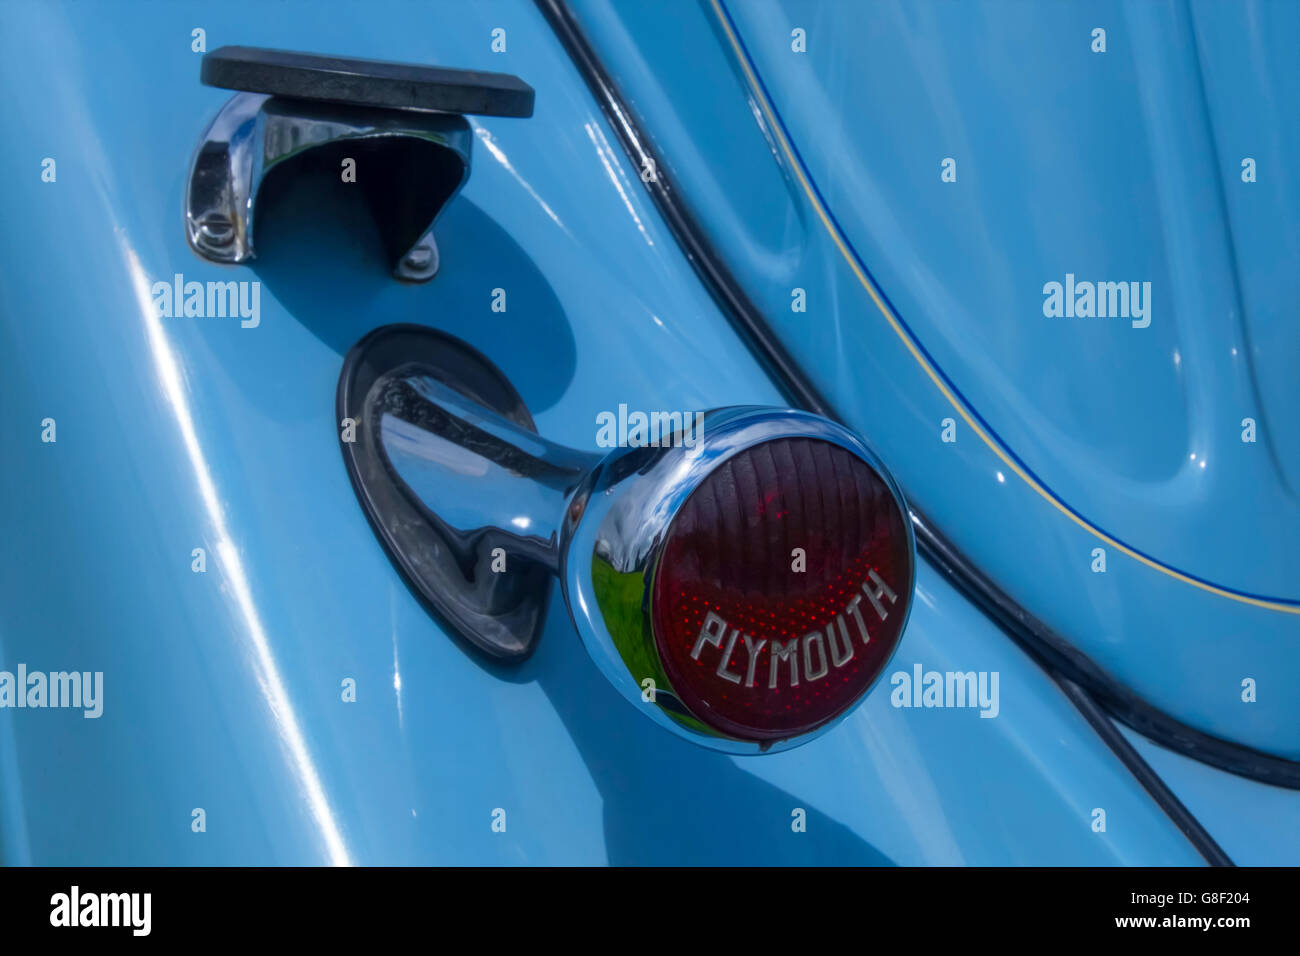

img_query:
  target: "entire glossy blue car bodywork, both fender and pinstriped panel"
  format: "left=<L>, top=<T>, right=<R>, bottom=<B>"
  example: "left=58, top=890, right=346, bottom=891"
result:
left=0, top=0, right=1300, bottom=865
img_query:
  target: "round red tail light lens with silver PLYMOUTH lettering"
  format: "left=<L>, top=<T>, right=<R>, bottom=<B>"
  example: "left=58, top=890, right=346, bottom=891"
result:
left=651, top=438, right=913, bottom=740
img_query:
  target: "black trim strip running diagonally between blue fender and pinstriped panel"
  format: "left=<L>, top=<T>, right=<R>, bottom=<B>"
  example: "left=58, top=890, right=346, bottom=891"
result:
left=536, top=0, right=1300, bottom=862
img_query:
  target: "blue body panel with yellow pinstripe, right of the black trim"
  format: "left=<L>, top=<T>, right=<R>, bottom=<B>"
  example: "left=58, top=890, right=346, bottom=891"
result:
left=576, top=0, right=1300, bottom=758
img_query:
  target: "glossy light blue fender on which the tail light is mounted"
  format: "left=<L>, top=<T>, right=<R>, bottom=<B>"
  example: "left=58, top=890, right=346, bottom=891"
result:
left=0, top=3, right=1199, bottom=864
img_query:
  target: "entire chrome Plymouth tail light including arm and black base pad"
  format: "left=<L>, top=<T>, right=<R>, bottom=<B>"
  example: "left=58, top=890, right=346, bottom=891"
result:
left=338, top=325, right=915, bottom=753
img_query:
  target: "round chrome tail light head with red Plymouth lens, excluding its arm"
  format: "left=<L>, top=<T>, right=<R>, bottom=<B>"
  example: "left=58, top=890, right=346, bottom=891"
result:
left=563, top=408, right=915, bottom=753
